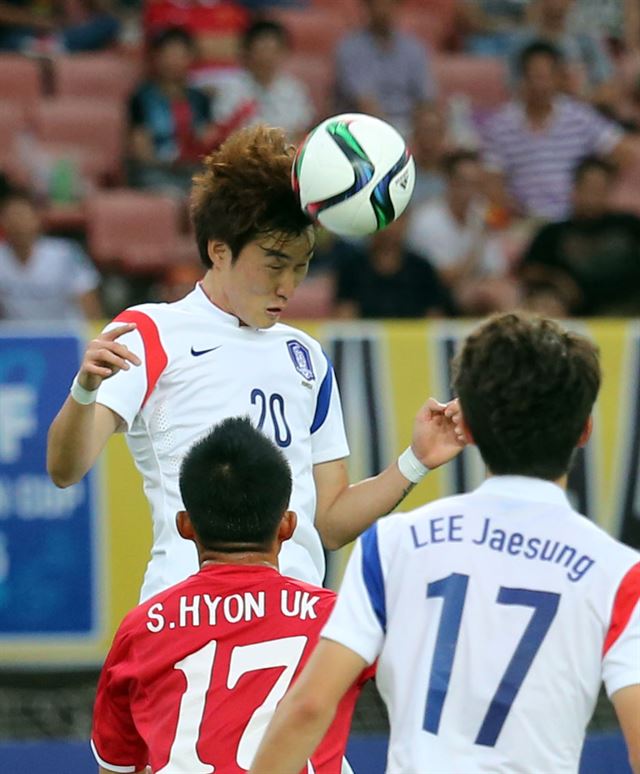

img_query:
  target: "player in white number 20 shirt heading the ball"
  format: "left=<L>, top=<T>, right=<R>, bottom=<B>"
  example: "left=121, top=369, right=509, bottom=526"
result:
left=47, top=126, right=462, bottom=599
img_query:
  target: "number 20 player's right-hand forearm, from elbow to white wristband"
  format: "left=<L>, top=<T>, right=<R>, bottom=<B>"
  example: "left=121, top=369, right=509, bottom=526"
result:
left=316, top=462, right=415, bottom=550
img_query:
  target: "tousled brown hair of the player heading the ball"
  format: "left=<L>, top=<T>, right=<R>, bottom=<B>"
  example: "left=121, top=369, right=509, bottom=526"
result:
left=191, top=125, right=311, bottom=268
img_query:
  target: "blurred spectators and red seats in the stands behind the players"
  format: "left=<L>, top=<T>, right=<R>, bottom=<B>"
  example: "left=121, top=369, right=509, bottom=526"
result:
left=0, top=0, right=640, bottom=319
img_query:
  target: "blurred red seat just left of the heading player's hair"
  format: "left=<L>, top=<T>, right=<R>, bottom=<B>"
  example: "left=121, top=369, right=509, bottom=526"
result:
left=86, top=189, right=197, bottom=274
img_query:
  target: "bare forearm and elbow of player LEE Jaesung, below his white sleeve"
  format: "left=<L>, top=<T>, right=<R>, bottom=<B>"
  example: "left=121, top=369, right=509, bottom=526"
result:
left=249, top=688, right=336, bottom=774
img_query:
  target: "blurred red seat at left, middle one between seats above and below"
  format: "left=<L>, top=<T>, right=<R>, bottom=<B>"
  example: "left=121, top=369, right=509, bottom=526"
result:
left=33, top=97, right=125, bottom=180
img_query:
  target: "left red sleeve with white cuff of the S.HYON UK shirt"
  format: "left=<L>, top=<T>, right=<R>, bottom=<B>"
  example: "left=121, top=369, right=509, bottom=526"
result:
left=91, top=628, right=149, bottom=772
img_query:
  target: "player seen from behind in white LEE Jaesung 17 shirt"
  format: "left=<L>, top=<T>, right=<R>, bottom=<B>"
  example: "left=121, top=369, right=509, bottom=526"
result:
left=251, top=314, right=640, bottom=774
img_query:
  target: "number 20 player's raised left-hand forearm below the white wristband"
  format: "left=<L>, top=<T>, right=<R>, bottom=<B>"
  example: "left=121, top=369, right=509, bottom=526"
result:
left=47, top=396, right=105, bottom=487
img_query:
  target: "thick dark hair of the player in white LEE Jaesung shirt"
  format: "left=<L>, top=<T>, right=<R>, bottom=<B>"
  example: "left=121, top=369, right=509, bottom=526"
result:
left=453, top=313, right=601, bottom=481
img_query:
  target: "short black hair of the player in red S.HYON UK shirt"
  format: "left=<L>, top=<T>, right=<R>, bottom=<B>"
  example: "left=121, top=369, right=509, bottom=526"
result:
left=180, top=417, right=291, bottom=551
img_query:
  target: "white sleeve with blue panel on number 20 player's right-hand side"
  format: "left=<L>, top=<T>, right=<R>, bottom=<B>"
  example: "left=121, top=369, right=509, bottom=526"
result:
left=311, top=355, right=349, bottom=465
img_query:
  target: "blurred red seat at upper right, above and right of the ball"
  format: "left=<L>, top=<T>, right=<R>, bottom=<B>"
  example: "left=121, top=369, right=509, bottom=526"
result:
left=433, top=54, right=509, bottom=109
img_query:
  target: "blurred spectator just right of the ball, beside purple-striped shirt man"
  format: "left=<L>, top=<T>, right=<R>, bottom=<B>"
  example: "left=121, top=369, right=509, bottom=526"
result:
left=411, top=105, right=447, bottom=207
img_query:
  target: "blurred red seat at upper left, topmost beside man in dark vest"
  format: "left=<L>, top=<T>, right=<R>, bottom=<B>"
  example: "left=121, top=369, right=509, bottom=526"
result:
left=53, top=53, right=141, bottom=100
